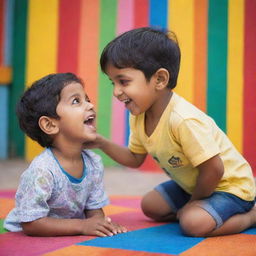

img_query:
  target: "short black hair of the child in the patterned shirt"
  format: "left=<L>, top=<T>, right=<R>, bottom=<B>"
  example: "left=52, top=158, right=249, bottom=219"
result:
left=16, top=73, right=83, bottom=147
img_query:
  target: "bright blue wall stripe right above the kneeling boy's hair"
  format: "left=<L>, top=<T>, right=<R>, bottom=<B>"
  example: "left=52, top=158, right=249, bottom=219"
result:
left=149, top=0, right=168, bottom=29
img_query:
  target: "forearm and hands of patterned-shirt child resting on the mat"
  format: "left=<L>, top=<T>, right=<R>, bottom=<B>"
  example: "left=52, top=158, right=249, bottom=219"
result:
left=21, top=209, right=126, bottom=236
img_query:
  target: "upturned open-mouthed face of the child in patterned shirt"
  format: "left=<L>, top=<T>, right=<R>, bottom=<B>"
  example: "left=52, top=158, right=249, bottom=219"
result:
left=56, top=82, right=96, bottom=143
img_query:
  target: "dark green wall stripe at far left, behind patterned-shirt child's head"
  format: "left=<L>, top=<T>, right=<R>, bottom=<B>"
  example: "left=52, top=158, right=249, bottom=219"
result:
left=9, top=0, right=28, bottom=157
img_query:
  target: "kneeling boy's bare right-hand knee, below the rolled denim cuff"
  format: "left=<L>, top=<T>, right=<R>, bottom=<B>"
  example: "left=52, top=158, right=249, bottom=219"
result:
left=179, top=207, right=216, bottom=237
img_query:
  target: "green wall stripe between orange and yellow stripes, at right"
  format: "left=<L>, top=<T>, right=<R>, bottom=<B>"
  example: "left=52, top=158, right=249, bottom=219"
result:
left=207, top=0, right=228, bottom=132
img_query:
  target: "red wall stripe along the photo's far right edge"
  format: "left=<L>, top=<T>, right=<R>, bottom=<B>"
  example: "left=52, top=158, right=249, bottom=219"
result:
left=243, top=0, right=256, bottom=175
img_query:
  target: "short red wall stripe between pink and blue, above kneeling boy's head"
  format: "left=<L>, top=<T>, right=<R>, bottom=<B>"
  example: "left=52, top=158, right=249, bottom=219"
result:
left=134, top=0, right=149, bottom=28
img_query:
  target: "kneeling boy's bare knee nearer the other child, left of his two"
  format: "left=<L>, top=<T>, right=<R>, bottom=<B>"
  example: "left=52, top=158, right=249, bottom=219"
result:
left=141, top=190, right=176, bottom=221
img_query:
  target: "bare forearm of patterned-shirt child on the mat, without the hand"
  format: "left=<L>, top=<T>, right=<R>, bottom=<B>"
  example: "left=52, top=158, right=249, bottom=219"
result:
left=22, top=217, right=84, bottom=236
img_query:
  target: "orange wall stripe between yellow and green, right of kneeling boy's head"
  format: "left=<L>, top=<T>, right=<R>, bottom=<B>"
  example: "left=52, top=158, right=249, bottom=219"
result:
left=194, top=0, right=208, bottom=111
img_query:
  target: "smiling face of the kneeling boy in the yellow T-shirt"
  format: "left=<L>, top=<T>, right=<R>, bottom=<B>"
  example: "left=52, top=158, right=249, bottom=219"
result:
left=106, top=64, right=157, bottom=115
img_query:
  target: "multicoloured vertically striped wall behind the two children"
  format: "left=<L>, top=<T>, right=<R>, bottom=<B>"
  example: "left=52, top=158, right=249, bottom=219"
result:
left=0, top=0, right=256, bottom=173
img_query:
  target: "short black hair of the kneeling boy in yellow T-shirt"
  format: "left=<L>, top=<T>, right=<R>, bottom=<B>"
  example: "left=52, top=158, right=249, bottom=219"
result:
left=100, top=27, right=181, bottom=89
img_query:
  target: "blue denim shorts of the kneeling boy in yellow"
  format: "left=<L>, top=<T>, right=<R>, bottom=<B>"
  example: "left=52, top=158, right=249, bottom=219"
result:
left=155, top=180, right=255, bottom=228
